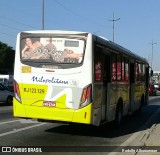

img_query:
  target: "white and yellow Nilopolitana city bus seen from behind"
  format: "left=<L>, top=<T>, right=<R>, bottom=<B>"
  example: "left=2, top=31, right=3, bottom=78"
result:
left=13, top=30, right=149, bottom=126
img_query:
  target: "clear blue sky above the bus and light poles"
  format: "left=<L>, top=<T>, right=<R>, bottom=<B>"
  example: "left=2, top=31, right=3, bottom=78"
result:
left=0, top=0, right=160, bottom=71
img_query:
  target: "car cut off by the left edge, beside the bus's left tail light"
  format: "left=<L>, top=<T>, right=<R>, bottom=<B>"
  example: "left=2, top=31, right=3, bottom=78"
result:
left=0, top=83, right=14, bottom=105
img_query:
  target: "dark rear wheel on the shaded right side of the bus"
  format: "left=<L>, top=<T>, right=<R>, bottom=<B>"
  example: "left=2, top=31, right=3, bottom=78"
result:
left=115, top=104, right=123, bottom=125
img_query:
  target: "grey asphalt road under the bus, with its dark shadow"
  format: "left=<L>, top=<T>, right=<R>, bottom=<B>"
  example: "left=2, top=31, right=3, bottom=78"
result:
left=0, top=96, right=160, bottom=152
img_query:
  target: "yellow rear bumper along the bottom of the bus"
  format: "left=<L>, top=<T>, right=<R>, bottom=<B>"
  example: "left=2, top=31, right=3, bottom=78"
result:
left=13, top=98, right=92, bottom=124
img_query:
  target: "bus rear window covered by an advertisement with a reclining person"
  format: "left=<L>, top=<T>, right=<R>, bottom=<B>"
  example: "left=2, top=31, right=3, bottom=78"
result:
left=20, top=36, right=85, bottom=64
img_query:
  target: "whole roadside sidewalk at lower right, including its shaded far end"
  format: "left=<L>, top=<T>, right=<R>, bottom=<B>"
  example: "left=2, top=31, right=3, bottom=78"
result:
left=111, top=109, right=160, bottom=155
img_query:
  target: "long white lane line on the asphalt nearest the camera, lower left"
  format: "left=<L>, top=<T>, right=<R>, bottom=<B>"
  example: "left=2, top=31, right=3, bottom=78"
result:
left=0, top=123, right=46, bottom=137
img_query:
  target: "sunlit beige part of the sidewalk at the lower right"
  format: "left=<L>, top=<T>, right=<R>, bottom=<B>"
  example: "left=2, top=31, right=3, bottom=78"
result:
left=112, top=123, right=160, bottom=155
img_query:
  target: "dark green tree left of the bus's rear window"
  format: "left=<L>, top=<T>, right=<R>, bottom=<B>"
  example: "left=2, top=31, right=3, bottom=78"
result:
left=0, top=42, right=15, bottom=74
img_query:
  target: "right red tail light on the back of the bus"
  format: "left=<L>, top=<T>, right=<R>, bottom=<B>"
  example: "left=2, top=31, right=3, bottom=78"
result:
left=81, top=85, right=91, bottom=107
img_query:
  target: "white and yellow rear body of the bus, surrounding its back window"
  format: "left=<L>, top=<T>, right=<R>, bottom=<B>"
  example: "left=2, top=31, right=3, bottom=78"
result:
left=13, top=33, right=92, bottom=124
